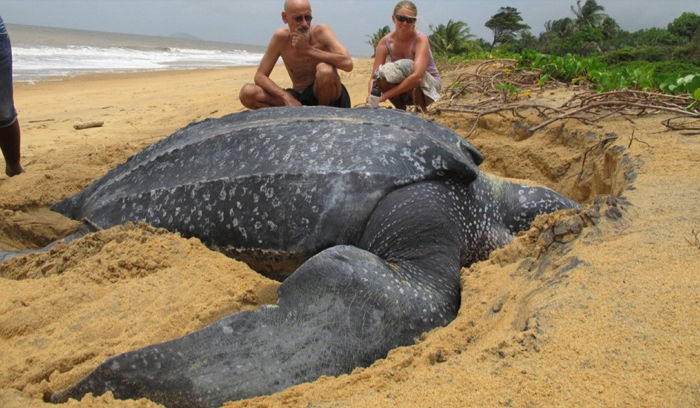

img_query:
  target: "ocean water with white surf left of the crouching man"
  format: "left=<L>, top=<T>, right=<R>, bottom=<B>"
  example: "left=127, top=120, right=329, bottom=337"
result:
left=6, top=24, right=265, bottom=82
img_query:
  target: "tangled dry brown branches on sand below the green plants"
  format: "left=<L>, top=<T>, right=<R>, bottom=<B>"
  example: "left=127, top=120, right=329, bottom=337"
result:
left=430, top=60, right=700, bottom=133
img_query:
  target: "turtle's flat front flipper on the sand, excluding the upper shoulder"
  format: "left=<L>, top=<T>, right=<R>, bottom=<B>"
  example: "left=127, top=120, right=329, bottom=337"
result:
left=49, top=241, right=456, bottom=408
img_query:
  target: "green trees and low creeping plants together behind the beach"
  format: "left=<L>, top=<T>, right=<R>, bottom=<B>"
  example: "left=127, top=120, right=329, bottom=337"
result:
left=366, top=0, right=700, bottom=100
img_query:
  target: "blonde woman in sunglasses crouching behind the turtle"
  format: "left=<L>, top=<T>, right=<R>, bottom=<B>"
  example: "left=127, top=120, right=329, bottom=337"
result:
left=368, top=1, right=440, bottom=112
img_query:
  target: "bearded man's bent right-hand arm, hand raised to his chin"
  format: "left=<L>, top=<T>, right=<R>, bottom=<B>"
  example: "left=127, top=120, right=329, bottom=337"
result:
left=291, top=24, right=352, bottom=72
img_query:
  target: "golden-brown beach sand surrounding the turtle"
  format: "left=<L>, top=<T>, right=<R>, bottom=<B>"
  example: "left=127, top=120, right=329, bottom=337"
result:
left=0, top=60, right=700, bottom=408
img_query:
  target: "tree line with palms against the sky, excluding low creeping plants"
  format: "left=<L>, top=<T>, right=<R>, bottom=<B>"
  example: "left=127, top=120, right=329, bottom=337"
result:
left=368, top=0, right=700, bottom=67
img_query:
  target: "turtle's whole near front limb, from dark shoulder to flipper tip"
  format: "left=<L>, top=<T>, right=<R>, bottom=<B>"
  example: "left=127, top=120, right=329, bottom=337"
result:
left=51, top=183, right=470, bottom=408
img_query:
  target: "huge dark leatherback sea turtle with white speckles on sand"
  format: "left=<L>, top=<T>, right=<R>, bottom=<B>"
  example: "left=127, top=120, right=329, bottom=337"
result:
left=30, top=107, right=578, bottom=407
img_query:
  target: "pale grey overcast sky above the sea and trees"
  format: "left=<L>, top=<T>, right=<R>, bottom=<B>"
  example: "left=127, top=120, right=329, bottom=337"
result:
left=0, top=0, right=700, bottom=56
